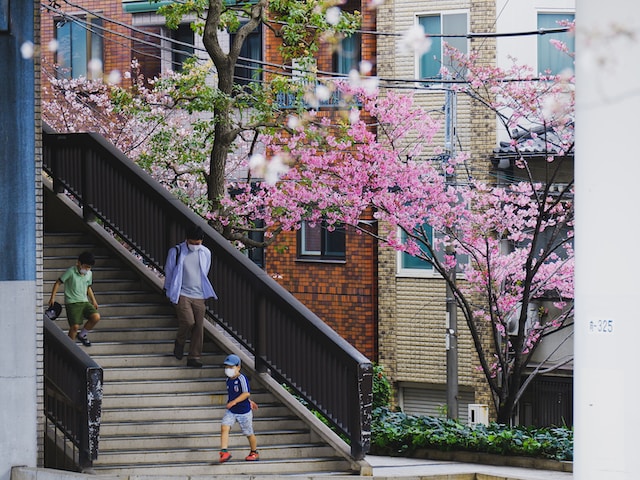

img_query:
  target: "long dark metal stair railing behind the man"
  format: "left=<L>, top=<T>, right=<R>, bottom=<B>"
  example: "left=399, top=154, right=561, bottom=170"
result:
left=43, top=128, right=373, bottom=460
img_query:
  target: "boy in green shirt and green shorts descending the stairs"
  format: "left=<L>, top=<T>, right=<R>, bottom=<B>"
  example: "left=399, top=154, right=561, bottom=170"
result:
left=49, top=252, right=100, bottom=347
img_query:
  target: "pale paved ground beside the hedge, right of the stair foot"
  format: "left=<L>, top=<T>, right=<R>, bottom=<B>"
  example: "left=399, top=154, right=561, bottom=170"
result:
left=366, top=455, right=573, bottom=480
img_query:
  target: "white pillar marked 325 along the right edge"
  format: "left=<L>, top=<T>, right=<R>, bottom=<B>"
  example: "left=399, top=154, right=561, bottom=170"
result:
left=574, top=0, right=640, bottom=480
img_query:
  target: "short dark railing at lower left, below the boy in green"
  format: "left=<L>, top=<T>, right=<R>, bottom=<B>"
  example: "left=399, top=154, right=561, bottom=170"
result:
left=44, top=315, right=103, bottom=471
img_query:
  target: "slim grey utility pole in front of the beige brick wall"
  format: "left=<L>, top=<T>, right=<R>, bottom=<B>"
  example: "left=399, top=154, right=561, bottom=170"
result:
left=444, top=89, right=458, bottom=420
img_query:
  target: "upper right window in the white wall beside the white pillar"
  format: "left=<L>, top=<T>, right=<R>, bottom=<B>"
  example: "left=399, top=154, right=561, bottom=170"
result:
left=538, top=13, right=575, bottom=75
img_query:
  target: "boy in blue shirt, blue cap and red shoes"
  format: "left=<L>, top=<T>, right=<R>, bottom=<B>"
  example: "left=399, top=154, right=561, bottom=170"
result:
left=220, top=354, right=260, bottom=463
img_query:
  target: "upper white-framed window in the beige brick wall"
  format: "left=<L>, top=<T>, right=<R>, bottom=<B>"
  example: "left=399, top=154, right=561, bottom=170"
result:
left=418, top=13, right=468, bottom=78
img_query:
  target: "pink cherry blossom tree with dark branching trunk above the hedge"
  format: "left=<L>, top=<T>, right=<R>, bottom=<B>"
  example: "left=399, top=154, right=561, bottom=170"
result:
left=227, top=50, right=573, bottom=423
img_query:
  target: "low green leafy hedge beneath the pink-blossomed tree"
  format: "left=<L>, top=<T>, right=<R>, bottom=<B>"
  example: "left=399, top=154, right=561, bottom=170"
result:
left=371, top=407, right=573, bottom=460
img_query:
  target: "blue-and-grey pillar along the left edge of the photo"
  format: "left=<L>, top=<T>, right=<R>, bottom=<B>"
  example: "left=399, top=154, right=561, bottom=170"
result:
left=0, top=0, right=42, bottom=480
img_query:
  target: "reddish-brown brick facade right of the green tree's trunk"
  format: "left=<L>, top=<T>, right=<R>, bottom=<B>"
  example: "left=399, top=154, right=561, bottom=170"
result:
left=265, top=0, right=378, bottom=361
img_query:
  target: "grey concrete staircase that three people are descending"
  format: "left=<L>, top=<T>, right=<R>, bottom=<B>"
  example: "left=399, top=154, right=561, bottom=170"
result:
left=44, top=230, right=359, bottom=477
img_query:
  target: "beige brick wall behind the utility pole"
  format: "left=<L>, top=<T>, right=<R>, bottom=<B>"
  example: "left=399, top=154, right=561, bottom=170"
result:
left=378, top=0, right=496, bottom=413
